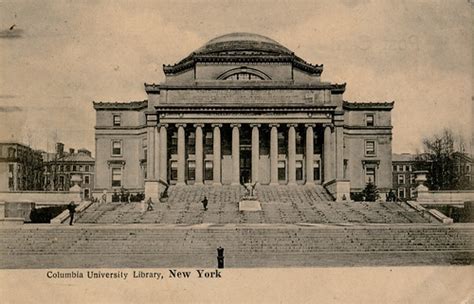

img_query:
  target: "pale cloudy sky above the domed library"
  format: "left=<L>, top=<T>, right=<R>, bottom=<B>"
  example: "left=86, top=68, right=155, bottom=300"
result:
left=0, top=0, right=474, bottom=153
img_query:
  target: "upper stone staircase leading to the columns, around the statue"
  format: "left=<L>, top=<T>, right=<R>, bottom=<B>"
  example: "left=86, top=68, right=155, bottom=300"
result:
left=77, top=185, right=429, bottom=225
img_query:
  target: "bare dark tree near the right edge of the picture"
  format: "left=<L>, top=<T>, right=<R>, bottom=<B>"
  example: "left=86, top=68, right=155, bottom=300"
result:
left=415, top=129, right=468, bottom=190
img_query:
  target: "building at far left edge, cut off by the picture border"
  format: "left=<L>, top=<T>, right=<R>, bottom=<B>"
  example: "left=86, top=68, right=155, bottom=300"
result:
left=0, top=142, right=43, bottom=191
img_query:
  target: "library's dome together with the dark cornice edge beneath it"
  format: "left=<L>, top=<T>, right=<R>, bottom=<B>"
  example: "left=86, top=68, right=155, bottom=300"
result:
left=163, top=33, right=323, bottom=76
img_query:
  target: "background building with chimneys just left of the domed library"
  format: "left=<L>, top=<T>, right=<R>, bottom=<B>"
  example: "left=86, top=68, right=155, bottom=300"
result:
left=43, top=143, right=95, bottom=199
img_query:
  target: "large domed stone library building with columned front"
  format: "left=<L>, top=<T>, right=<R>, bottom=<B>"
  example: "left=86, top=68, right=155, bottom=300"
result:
left=94, top=33, right=393, bottom=199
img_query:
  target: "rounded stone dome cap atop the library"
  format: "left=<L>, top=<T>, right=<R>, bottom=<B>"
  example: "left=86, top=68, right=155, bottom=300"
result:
left=193, top=33, right=292, bottom=55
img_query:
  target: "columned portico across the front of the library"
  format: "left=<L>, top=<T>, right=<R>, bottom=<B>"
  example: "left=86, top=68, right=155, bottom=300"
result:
left=143, top=108, right=343, bottom=185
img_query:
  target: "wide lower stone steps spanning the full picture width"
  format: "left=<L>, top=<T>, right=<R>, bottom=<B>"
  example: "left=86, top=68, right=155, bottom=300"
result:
left=0, top=224, right=474, bottom=268
